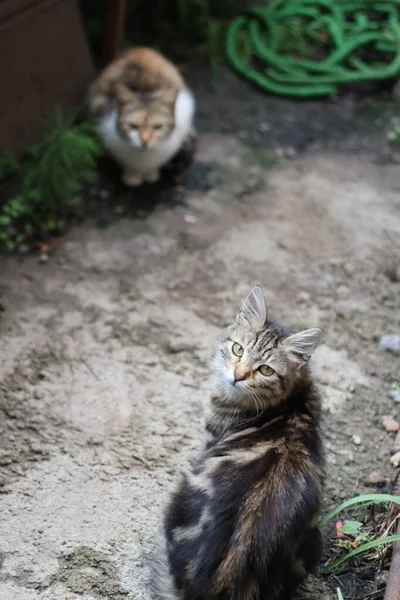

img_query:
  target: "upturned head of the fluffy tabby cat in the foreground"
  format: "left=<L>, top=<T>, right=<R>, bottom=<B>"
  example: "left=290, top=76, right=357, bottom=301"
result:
left=214, top=287, right=321, bottom=410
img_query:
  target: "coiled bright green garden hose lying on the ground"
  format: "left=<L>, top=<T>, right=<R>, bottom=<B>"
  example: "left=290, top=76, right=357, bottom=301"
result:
left=226, top=0, right=400, bottom=97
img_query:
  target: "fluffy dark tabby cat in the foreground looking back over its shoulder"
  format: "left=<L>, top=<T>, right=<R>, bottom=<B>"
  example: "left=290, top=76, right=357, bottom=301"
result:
left=153, top=288, right=324, bottom=600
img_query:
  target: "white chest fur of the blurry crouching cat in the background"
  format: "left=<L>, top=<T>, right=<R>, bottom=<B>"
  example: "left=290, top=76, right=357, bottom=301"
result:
left=98, top=89, right=195, bottom=174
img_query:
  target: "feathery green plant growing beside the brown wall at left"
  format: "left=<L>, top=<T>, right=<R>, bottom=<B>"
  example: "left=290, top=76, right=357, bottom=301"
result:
left=0, top=109, right=102, bottom=251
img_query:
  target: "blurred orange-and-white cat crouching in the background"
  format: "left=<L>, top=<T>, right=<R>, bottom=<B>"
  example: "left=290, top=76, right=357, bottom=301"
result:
left=89, top=48, right=195, bottom=186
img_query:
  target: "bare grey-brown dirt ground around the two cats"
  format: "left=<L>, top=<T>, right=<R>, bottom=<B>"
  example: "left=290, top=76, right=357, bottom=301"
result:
left=0, top=68, right=400, bottom=600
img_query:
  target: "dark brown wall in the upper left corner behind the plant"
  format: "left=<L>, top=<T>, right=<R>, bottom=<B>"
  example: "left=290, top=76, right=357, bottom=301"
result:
left=0, top=0, right=94, bottom=154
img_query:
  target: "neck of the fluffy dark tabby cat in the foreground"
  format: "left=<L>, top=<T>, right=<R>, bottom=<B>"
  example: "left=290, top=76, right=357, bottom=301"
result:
left=205, top=376, right=320, bottom=445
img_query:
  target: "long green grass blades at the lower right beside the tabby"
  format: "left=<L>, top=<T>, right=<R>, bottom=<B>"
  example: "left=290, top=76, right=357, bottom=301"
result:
left=321, top=494, right=400, bottom=572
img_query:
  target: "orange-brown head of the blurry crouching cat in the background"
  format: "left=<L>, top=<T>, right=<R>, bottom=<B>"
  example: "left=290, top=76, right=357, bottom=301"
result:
left=114, top=83, right=177, bottom=148
